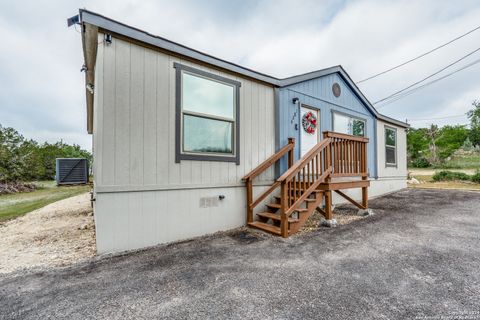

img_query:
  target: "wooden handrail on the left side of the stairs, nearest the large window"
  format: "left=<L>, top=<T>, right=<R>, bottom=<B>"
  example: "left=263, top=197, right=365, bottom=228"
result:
left=242, top=138, right=295, bottom=223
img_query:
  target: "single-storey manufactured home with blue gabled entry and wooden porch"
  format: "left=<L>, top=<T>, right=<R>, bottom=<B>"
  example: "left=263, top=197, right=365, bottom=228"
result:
left=76, top=10, right=408, bottom=253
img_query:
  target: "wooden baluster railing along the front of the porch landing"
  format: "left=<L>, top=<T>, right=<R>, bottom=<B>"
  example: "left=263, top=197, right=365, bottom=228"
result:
left=323, top=131, right=368, bottom=178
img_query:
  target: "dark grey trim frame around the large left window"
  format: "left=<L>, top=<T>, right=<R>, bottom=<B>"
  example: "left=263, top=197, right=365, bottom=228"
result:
left=173, top=62, right=241, bottom=165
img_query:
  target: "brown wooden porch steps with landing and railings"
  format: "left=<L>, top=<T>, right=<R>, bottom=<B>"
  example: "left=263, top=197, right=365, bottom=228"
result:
left=243, top=131, right=369, bottom=237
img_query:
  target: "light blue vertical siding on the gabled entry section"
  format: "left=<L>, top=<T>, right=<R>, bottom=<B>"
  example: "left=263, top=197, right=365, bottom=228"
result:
left=277, top=74, right=377, bottom=177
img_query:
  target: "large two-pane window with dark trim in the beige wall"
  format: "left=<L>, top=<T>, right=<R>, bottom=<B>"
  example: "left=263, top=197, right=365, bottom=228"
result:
left=174, top=63, right=240, bottom=164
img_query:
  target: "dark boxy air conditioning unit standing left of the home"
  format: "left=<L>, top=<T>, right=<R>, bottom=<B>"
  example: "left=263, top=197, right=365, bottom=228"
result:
left=55, top=158, right=88, bottom=185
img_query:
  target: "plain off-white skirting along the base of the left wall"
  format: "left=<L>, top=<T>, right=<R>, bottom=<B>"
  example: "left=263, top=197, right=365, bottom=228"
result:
left=95, top=186, right=271, bottom=253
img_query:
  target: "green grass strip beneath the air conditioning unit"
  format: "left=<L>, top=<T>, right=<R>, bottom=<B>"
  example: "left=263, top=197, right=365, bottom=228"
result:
left=0, top=181, right=90, bottom=221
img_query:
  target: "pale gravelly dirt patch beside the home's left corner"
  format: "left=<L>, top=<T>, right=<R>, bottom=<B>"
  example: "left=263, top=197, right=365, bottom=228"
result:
left=0, top=193, right=95, bottom=273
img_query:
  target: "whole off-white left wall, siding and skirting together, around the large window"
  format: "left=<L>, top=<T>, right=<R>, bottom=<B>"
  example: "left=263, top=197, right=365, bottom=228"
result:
left=93, top=35, right=275, bottom=253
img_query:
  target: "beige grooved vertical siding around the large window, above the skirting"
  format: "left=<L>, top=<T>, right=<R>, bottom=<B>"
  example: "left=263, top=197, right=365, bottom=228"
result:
left=94, top=35, right=275, bottom=191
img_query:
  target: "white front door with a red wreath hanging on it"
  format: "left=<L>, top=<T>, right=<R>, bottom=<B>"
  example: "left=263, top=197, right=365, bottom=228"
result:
left=300, top=106, right=320, bottom=157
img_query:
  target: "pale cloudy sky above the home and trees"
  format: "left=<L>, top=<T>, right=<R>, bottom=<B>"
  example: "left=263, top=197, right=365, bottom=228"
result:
left=0, top=0, right=480, bottom=149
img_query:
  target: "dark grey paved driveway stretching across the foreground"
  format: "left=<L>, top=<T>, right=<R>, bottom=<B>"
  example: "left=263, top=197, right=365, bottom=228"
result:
left=0, top=189, right=480, bottom=320
